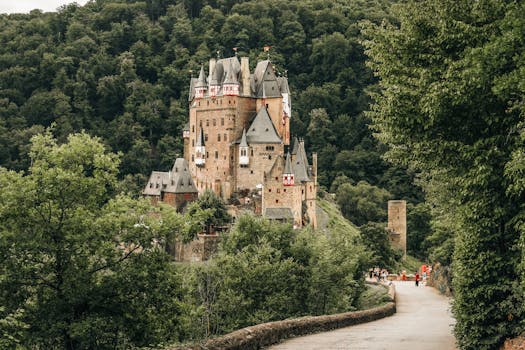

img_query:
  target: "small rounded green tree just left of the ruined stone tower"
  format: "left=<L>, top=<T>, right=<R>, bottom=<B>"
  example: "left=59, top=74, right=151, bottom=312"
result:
left=337, top=181, right=392, bottom=226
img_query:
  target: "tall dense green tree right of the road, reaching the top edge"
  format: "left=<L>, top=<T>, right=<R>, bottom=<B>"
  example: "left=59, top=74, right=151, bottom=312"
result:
left=364, top=0, right=525, bottom=349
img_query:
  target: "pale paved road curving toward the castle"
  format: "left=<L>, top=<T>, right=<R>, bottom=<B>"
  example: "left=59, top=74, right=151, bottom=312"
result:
left=268, top=282, right=456, bottom=350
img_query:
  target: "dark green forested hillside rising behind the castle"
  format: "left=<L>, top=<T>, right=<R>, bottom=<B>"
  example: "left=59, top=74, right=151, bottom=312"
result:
left=0, top=0, right=421, bottom=201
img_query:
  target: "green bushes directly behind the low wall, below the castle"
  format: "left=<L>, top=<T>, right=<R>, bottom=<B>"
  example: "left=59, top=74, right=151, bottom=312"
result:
left=178, top=215, right=365, bottom=339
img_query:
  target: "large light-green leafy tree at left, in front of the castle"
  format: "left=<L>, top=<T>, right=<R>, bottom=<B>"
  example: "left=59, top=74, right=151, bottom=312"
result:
left=0, top=131, right=183, bottom=349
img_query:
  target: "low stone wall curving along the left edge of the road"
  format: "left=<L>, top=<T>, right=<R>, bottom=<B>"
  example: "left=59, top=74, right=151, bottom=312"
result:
left=167, top=284, right=396, bottom=350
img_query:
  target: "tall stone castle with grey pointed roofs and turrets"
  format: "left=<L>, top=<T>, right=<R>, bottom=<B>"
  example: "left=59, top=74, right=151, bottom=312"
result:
left=143, top=56, right=317, bottom=227
